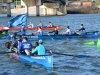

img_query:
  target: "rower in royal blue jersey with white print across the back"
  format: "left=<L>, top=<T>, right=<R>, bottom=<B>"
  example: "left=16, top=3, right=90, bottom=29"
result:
left=20, top=37, right=32, bottom=55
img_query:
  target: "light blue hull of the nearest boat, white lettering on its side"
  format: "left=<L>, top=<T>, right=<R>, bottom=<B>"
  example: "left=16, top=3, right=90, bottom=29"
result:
left=9, top=49, right=53, bottom=68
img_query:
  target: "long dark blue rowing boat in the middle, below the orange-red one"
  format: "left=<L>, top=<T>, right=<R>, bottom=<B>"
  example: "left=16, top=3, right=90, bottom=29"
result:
left=19, top=31, right=98, bottom=39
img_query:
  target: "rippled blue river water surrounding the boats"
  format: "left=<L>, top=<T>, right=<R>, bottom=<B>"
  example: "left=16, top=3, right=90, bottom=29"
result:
left=0, top=14, right=100, bottom=75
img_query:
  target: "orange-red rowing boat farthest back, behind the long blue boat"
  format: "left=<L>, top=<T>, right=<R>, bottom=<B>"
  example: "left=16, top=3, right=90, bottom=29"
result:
left=9, top=25, right=61, bottom=30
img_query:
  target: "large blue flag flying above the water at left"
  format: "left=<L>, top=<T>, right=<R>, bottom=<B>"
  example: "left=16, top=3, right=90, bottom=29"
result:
left=8, top=14, right=26, bottom=28
